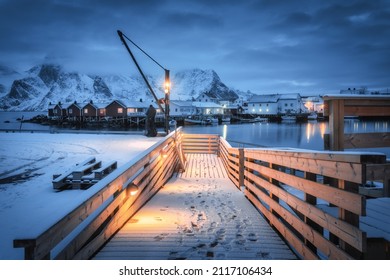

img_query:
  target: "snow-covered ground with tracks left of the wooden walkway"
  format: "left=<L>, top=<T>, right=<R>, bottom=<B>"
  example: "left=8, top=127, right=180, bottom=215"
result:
left=0, top=133, right=161, bottom=260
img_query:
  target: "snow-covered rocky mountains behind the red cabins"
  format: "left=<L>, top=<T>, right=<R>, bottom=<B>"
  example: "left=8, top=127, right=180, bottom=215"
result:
left=0, top=64, right=240, bottom=111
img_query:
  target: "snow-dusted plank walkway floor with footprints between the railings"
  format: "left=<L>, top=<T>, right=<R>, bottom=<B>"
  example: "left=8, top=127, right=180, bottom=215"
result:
left=94, top=154, right=297, bottom=260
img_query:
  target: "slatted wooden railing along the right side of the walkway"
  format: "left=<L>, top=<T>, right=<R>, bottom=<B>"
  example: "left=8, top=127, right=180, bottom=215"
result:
left=220, top=139, right=386, bottom=259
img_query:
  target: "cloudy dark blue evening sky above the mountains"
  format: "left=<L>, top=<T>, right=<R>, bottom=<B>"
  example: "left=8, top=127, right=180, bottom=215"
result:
left=0, top=0, right=390, bottom=94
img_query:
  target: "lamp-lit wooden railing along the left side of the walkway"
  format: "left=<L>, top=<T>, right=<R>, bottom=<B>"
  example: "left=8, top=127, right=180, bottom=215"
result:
left=14, top=129, right=181, bottom=259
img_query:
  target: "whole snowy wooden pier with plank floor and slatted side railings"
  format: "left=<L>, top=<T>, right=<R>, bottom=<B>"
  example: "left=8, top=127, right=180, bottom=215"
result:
left=14, top=129, right=390, bottom=259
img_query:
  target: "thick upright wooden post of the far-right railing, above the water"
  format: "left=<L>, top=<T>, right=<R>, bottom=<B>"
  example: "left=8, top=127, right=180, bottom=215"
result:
left=329, top=99, right=344, bottom=151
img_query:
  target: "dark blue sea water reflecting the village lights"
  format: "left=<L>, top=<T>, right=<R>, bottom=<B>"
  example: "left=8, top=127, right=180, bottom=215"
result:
left=0, top=112, right=390, bottom=157
